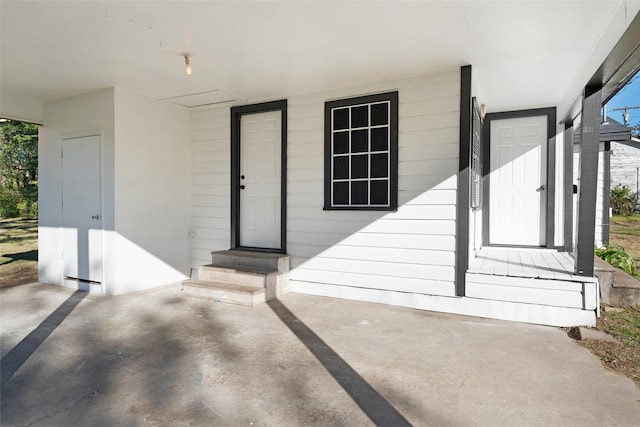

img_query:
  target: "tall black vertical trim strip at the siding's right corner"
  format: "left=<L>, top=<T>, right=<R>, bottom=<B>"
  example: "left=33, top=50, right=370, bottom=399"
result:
left=455, top=65, right=473, bottom=297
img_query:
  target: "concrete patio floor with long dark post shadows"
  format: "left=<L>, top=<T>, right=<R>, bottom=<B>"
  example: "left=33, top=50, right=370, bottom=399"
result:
left=0, top=284, right=640, bottom=427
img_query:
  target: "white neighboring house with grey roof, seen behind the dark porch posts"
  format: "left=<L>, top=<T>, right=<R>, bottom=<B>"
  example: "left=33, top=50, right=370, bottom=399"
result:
left=573, top=117, right=640, bottom=246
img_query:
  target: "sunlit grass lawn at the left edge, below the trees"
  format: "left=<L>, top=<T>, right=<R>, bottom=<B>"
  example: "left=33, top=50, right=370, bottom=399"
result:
left=0, top=218, right=38, bottom=288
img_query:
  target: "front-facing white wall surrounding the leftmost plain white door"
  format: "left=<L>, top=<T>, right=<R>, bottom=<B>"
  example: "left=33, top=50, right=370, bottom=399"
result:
left=38, top=89, right=114, bottom=285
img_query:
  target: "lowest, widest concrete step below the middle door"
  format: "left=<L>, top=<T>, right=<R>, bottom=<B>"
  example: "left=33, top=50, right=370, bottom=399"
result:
left=182, top=279, right=267, bottom=307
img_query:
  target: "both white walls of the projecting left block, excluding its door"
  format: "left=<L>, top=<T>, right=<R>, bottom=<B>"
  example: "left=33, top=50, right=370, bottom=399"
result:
left=39, top=88, right=190, bottom=294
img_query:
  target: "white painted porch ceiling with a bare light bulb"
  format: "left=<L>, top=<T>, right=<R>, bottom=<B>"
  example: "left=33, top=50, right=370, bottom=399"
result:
left=0, top=0, right=640, bottom=121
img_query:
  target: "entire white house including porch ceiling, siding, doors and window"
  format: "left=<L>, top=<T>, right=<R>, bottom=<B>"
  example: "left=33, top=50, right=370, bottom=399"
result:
left=0, top=1, right=640, bottom=328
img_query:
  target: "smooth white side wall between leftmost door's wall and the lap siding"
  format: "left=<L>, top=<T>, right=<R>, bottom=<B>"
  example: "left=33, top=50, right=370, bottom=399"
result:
left=112, top=88, right=191, bottom=294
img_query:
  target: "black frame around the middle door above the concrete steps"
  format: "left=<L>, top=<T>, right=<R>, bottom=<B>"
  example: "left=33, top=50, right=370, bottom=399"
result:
left=231, top=99, right=287, bottom=254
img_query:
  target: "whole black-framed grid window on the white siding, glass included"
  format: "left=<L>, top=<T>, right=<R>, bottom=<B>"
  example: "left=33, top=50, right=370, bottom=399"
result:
left=324, top=92, right=398, bottom=210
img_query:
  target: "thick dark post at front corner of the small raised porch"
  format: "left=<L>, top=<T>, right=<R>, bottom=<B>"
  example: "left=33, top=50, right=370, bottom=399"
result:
left=574, top=85, right=602, bottom=276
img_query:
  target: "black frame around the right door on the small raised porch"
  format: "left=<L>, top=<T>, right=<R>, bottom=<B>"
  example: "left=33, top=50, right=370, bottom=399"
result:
left=482, top=107, right=556, bottom=248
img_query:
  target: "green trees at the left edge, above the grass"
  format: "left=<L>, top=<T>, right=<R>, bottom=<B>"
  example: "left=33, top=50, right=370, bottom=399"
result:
left=0, top=120, right=38, bottom=217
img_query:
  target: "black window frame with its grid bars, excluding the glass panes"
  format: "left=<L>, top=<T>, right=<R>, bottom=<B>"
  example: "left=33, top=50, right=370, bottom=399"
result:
left=323, top=91, right=398, bottom=211
